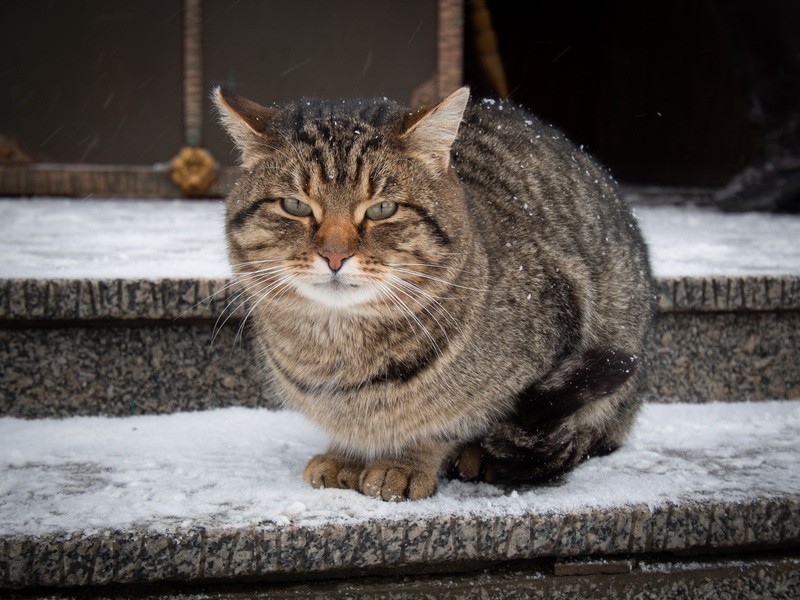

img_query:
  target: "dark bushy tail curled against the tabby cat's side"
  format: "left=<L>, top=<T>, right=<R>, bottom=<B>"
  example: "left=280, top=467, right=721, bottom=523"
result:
left=451, top=348, right=641, bottom=483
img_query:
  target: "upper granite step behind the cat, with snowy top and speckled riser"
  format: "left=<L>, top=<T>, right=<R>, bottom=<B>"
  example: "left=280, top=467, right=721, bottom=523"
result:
left=0, top=200, right=800, bottom=418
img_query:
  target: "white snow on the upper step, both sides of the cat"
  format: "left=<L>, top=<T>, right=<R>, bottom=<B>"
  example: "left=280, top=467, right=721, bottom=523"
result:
left=0, top=199, right=800, bottom=279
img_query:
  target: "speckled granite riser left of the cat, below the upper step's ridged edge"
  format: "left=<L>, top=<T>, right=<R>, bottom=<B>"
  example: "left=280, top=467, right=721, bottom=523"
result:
left=0, top=321, right=274, bottom=418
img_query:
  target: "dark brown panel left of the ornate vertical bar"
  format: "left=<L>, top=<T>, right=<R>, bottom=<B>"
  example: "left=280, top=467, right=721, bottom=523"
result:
left=0, top=0, right=183, bottom=164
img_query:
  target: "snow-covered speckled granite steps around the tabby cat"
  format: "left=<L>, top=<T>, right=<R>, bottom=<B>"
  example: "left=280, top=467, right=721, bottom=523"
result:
left=0, top=200, right=800, bottom=598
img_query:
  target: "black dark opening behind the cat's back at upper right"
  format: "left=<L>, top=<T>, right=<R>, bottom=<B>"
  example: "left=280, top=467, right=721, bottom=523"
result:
left=465, top=0, right=800, bottom=186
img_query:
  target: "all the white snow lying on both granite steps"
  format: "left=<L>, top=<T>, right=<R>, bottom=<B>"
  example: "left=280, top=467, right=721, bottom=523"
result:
left=0, top=199, right=800, bottom=535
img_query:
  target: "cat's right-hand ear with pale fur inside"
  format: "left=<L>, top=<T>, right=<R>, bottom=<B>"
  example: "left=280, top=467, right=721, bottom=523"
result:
left=400, top=86, right=469, bottom=169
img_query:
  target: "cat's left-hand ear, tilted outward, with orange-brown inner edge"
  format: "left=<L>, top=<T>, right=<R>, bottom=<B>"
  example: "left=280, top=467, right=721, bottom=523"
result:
left=212, top=87, right=278, bottom=166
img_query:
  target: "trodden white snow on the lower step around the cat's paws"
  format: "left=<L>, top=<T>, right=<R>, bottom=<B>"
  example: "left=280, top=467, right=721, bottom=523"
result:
left=0, top=400, right=800, bottom=535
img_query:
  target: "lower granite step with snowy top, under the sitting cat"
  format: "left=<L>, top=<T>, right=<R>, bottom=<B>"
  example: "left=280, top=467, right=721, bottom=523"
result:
left=0, top=400, right=800, bottom=589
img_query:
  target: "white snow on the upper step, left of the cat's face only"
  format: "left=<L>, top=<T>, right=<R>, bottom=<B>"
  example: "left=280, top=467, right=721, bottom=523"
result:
left=0, top=198, right=230, bottom=279
